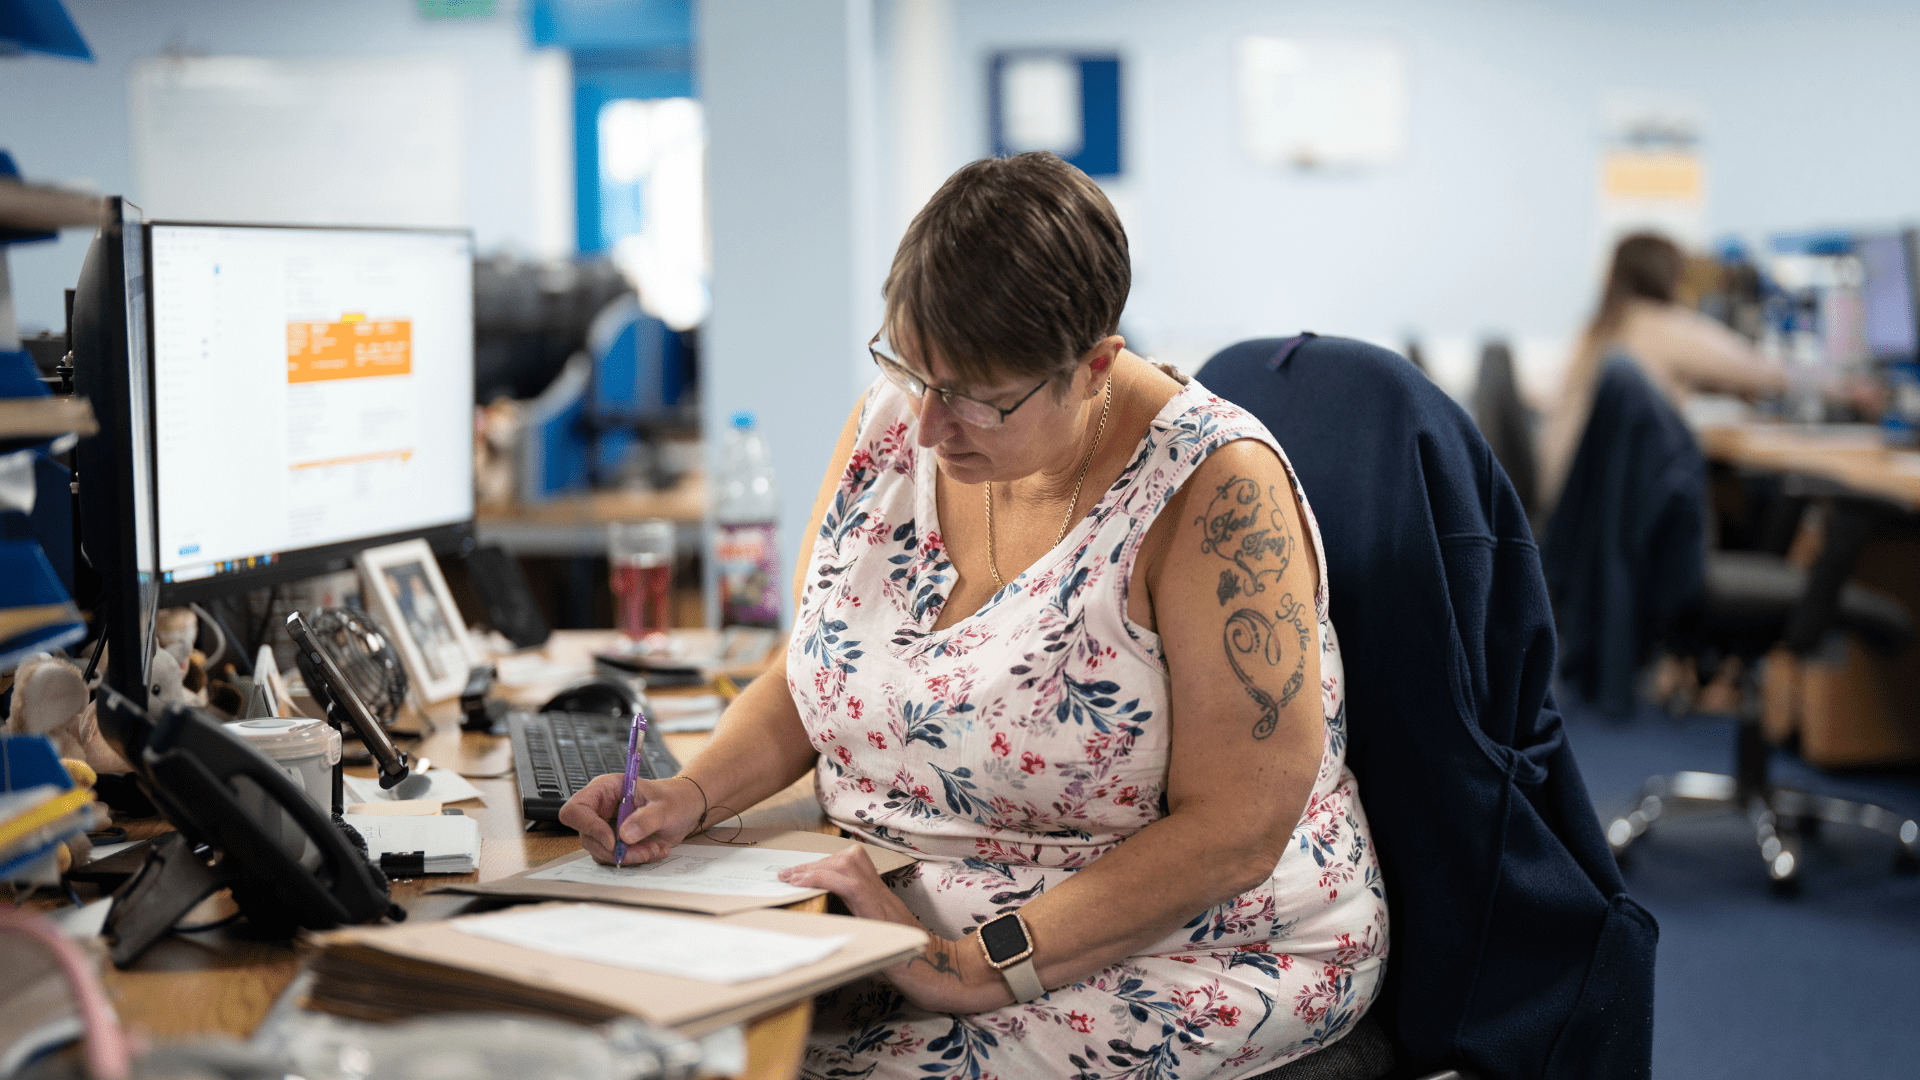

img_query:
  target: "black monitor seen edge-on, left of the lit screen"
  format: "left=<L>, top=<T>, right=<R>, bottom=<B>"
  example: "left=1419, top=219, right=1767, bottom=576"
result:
left=73, top=196, right=157, bottom=701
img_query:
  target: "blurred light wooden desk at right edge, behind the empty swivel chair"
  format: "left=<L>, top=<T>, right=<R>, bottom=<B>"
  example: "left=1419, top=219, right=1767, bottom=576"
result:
left=1697, top=423, right=1920, bottom=767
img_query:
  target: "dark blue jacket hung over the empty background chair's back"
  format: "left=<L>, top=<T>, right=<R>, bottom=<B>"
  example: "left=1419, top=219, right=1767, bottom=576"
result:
left=1542, top=354, right=1707, bottom=715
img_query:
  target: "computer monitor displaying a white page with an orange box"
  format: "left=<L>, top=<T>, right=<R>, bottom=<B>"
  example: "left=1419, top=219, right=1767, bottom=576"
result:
left=148, top=221, right=474, bottom=603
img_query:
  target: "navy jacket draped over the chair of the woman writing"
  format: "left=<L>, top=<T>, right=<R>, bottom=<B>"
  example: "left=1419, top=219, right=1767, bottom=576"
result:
left=1196, top=334, right=1657, bottom=1080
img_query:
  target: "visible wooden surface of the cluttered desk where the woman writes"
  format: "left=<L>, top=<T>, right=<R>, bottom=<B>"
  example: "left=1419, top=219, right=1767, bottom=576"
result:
left=74, top=630, right=826, bottom=1080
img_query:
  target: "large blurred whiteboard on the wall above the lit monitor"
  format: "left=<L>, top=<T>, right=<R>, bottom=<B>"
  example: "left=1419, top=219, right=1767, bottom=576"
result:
left=127, top=56, right=467, bottom=227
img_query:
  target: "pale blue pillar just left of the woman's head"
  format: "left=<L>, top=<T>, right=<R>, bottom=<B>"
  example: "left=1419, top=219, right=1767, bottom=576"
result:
left=695, top=0, right=881, bottom=617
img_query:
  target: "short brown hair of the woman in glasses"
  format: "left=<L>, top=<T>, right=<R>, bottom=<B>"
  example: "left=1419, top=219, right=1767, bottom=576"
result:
left=885, top=152, right=1133, bottom=382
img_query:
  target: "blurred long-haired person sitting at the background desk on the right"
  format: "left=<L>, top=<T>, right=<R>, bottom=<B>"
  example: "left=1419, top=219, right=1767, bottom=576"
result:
left=1540, top=233, right=1788, bottom=509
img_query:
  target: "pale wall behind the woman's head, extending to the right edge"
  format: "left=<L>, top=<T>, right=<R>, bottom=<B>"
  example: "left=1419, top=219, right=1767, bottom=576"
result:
left=887, top=0, right=1920, bottom=388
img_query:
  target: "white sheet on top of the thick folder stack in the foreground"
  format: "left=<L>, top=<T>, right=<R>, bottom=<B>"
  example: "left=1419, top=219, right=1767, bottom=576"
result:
left=451, top=903, right=852, bottom=984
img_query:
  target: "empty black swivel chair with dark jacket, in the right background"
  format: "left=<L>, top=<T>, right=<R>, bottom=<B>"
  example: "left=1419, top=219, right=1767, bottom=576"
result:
left=1544, top=356, right=1920, bottom=892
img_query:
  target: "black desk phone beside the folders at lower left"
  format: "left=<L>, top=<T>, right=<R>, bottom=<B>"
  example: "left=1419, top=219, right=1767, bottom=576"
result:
left=98, top=690, right=405, bottom=967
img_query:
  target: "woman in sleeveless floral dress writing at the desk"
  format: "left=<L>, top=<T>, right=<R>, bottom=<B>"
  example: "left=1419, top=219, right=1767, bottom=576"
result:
left=561, top=154, right=1386, bottom=1078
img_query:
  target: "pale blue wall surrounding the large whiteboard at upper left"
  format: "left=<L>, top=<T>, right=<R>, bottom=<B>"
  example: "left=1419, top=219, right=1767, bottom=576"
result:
left=0, top=0, right=556, bottom=331
